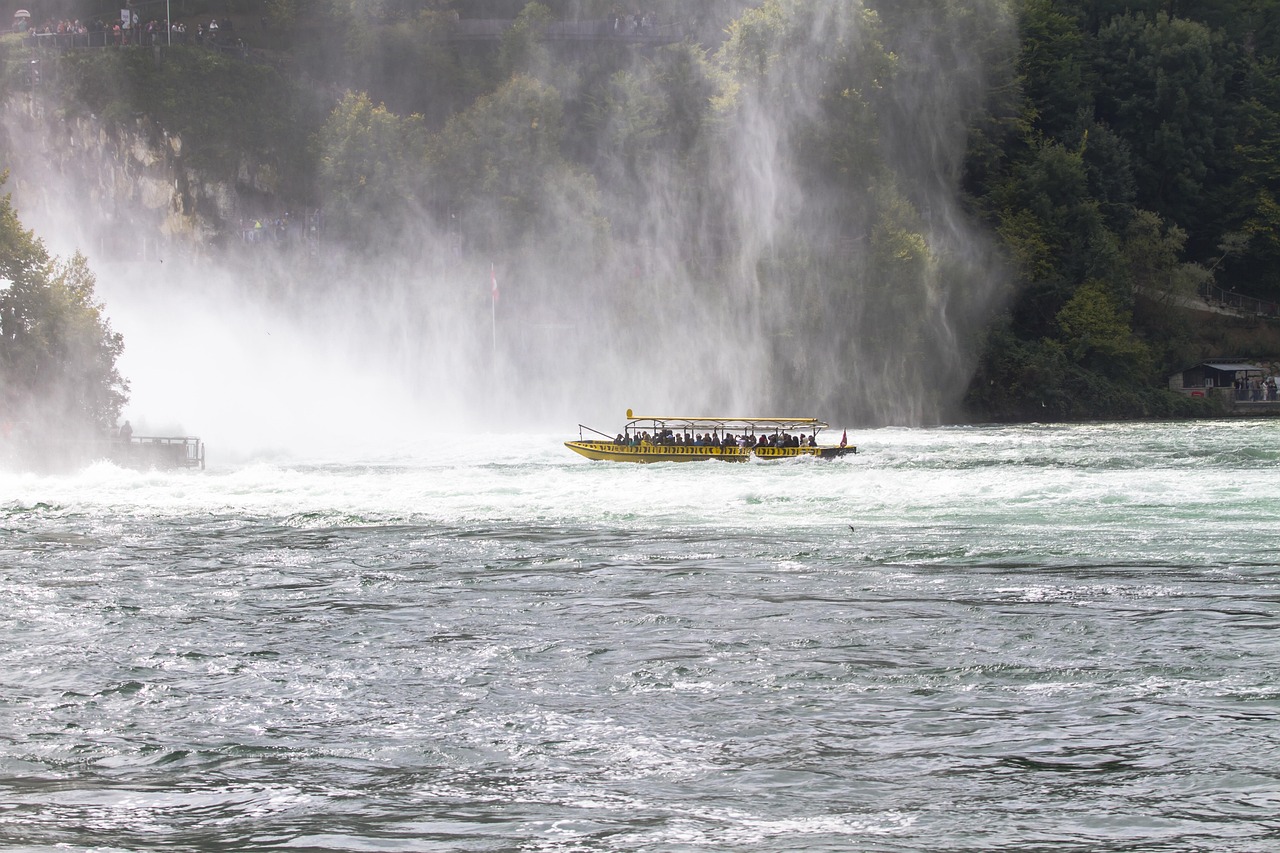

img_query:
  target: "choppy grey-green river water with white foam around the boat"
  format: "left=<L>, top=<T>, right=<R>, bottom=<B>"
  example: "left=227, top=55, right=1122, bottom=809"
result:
left=0, top=421, right=1280, bottom=852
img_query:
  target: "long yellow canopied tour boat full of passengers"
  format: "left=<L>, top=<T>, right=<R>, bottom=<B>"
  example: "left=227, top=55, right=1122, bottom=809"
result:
left=564, top=409, right=858, bottom=462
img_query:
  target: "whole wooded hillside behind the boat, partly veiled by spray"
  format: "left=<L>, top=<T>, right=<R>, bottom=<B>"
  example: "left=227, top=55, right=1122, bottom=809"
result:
left=5, top=0, right=1280, bottom=423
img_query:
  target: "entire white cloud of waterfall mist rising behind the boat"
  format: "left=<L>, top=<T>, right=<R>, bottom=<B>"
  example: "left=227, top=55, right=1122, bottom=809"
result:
left=8, top=0, right=1014, bottom=457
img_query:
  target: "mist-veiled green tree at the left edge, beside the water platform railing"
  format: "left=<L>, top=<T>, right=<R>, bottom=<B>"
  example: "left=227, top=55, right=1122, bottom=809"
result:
left=0, top=177, right=128, bottom=438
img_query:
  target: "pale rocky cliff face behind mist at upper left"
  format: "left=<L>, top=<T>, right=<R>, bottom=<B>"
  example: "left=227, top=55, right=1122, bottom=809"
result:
left=0, top=93, right=264, bottom=260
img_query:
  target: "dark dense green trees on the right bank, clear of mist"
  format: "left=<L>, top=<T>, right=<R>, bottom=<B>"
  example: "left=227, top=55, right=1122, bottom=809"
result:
left=966, top=0, right=1280, bottom=418
